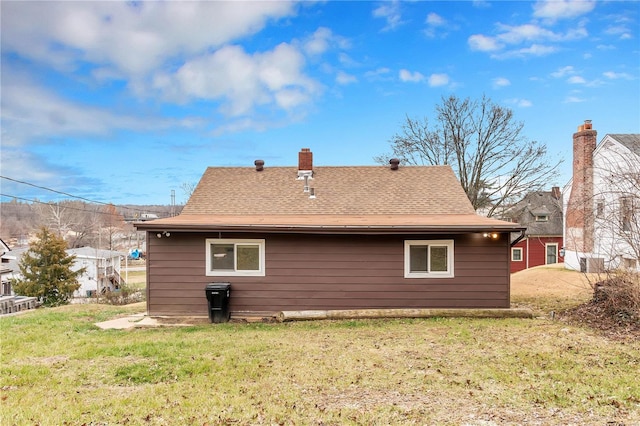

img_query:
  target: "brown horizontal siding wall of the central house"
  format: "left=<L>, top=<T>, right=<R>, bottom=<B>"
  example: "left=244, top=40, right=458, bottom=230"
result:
left=147, top=232, right=510, bottom=315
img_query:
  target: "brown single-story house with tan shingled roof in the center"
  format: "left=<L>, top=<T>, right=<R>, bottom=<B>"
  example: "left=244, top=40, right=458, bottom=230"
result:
left=135, top=148, right=523, bottom=317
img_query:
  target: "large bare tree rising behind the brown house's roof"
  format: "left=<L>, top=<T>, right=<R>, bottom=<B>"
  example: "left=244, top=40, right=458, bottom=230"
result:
left=375, top=95, right=561, bottom=216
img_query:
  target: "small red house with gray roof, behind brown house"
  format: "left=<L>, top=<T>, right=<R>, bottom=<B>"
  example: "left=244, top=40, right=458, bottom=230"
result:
left=503, top=186, right=564, bottom=273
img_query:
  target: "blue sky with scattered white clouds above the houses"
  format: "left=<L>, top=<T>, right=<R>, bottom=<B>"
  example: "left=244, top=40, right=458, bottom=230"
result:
left=0, top=0, right=640, bottom=204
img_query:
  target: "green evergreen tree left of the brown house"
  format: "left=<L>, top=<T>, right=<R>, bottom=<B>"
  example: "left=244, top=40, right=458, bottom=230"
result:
left=13, top=227, right=86, bottom=306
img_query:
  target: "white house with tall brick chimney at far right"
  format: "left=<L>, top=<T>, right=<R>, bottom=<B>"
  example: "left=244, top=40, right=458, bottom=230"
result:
left=563, top=120, right=640, bottom=272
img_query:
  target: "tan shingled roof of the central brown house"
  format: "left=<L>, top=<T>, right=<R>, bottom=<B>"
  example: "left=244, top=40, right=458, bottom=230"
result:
left=136, top=160, right=519, bottom=230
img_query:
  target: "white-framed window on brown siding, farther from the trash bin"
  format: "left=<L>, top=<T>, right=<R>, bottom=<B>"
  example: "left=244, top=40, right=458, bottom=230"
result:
left=404, top=240, right=453, bottom=278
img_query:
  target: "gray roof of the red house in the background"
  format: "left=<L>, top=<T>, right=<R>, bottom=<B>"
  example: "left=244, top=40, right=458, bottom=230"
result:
left=504, top=191, right=562, bottom=236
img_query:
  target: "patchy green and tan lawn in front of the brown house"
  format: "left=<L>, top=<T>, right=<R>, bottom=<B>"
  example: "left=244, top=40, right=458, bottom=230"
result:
left=0, top=304, right=640, bottom=426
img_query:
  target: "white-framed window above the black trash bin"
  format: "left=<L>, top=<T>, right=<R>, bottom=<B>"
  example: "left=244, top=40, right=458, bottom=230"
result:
left=206, top=238, right=264, bottom=277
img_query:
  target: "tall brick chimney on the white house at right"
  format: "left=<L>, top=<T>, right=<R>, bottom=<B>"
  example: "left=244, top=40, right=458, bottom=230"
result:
left=565, top=120, right=598, bottom=253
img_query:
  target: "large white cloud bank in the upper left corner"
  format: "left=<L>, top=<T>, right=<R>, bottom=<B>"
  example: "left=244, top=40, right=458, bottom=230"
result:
left=2, top=2, right=295, bottom=77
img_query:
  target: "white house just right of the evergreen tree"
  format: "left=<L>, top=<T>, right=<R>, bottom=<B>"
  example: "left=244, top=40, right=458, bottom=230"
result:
left=67, top=247, right=126, bottom=297
